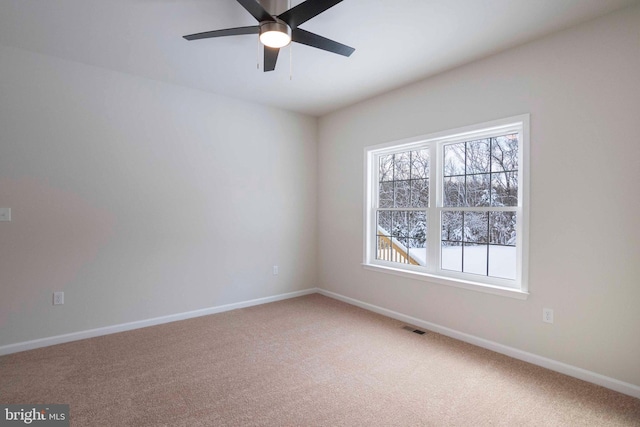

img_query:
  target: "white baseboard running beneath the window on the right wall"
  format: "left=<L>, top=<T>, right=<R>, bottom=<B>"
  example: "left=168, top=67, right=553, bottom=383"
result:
left=317, top=289, right=640, bottom=399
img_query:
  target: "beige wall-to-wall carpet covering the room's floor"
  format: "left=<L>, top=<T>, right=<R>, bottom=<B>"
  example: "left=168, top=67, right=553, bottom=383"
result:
left=0, top=294, right=640, bottom=426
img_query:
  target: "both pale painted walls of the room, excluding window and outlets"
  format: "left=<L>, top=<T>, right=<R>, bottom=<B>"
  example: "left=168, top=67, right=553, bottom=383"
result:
left=0, top=0, right=640, bottom=394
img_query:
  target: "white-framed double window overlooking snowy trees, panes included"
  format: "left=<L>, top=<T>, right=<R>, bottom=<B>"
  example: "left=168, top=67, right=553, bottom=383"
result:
left=365, top=115, right=529, bottom=297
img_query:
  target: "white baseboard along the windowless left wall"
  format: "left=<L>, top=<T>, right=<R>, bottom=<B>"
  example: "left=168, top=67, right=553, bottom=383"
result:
left=0, top=288, right=318, bottom=356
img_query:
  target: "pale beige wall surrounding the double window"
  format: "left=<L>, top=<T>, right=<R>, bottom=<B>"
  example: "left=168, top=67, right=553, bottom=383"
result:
left=318, top=6, right=640, bottom=385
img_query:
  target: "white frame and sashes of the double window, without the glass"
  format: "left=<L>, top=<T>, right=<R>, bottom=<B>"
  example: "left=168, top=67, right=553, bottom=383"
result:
left=363, top=114, right=529, bottom=299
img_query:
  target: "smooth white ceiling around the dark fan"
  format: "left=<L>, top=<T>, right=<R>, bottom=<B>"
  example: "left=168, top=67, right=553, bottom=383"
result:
left=0, top=0, right=638, bottom=116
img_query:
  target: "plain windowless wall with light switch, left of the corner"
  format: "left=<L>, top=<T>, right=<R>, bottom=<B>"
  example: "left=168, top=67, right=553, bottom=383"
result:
left=0, top=46, right=317, bottom=346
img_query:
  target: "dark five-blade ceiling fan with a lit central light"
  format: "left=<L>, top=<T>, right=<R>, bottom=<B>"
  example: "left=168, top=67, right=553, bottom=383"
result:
left=184, top=0, right=355, bottom=72
